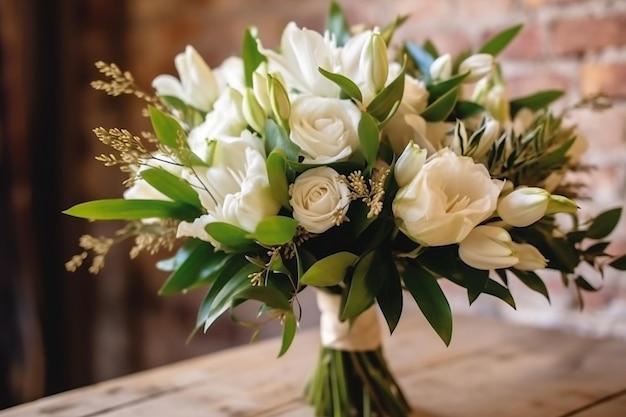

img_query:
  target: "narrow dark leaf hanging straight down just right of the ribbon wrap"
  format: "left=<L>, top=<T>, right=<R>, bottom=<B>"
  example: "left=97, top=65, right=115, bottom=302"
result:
left=376, top=253, right=403, bottom=333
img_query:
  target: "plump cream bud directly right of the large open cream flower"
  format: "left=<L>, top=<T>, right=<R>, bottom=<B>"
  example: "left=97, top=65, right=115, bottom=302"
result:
left=497, top=187, right=550, bottom=227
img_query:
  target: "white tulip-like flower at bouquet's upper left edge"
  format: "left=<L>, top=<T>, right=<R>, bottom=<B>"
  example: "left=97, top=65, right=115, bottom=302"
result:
left=152, top=45, right=219, bottom=111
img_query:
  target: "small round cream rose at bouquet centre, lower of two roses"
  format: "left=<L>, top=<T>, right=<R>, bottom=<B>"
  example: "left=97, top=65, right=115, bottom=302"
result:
left=289, top=166, right=350, bottom=233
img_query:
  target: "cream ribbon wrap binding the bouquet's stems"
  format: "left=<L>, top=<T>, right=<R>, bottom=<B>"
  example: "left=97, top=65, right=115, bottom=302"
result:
left=317, top=290, right=381, bottom=352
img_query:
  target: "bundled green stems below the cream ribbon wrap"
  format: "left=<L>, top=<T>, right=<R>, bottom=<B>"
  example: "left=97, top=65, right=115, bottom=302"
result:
left=305, top=347, right=410, bottom=417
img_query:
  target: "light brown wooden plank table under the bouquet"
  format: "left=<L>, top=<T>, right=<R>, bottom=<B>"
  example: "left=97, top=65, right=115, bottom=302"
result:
left=0, top=313, right=626, bottom=417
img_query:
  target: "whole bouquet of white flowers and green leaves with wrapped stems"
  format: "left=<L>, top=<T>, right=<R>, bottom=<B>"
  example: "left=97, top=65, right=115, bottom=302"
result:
left=65, top=3, right=626, bottom=416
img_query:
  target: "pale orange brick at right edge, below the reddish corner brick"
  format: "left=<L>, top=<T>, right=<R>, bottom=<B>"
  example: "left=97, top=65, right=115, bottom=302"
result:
left=580, top=63, right=626, bottom=98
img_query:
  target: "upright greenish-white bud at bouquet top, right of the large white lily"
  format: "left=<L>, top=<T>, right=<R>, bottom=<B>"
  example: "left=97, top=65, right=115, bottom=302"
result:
left=359, top=31, right=389, bottom=93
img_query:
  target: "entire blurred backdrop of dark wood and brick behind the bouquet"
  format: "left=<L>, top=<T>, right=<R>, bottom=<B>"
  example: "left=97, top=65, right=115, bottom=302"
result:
left=0, top=0, right=626, bottom=408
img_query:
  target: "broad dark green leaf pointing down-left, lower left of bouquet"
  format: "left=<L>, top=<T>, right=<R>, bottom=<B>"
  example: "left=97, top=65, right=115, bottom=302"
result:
left=159, top=241, right=233, bottom=295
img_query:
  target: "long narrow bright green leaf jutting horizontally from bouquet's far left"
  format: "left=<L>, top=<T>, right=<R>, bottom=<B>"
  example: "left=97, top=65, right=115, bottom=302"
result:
left=63, top=198, right=202, bottom=221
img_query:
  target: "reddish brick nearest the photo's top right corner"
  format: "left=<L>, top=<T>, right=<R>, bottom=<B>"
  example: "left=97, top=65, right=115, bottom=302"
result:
left=552, top=14, right=626, bottom=55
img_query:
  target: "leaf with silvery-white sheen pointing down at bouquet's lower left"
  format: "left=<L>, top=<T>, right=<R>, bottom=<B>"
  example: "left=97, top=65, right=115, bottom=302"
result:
left=197, top=260, right=259, bottom=332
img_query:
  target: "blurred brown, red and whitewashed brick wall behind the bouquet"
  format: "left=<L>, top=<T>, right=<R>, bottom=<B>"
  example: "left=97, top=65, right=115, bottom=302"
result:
left=89, top=0, right=626, bottom=376
